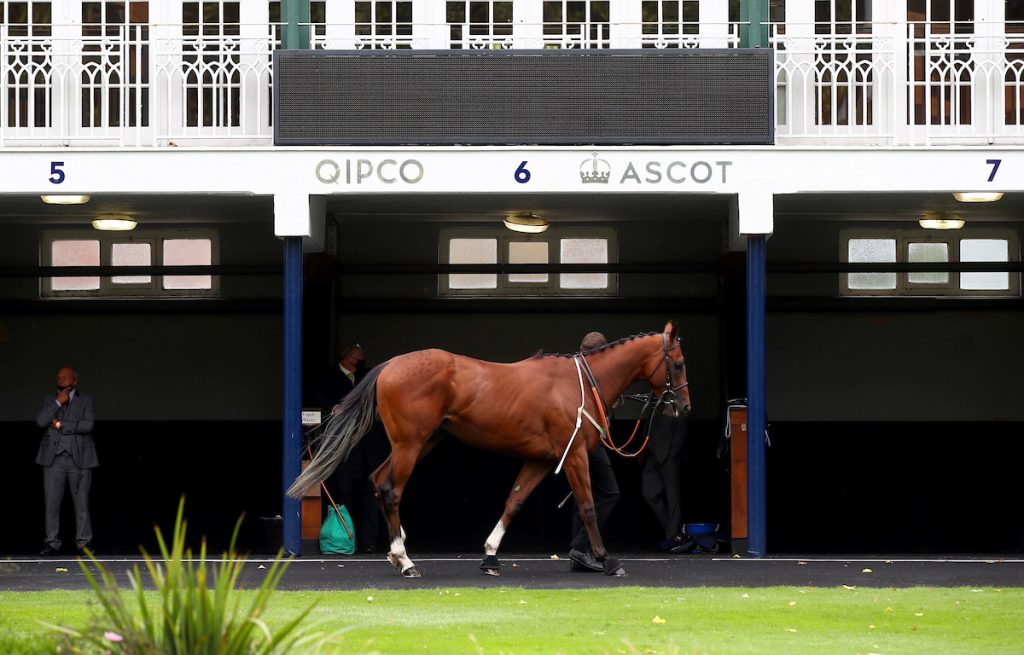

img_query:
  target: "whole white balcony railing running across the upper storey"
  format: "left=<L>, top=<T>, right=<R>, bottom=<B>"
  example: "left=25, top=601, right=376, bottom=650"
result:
left=6, top=21, right=1024, bottom=147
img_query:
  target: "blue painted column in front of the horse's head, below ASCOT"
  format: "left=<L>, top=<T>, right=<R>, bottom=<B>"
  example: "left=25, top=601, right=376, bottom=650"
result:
left=746, top=234, right=768, bottom=557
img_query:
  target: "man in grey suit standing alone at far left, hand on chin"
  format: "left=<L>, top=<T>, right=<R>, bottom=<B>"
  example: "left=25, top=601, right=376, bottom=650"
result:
left=36, top=366, right=99, bottom=557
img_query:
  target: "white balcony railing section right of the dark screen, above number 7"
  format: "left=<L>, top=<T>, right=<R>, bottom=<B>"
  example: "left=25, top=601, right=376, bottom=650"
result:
left=770, top=23, right=1024, bottom=145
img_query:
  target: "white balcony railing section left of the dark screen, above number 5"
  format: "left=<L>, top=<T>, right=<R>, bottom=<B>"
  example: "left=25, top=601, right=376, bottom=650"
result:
left=0, top=25, right=278, bottom=146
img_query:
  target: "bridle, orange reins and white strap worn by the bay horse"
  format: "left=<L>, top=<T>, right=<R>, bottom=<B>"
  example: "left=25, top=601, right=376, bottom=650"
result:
left=555, top=334, right=689, bottom=462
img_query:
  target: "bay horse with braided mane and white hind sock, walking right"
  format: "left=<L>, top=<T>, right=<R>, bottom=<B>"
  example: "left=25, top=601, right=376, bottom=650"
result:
left=288, top=320, right=690, bottom=577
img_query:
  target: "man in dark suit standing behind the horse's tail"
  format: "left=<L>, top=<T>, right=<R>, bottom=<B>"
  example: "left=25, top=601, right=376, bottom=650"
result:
left=316, top=344, right=389, bottom=553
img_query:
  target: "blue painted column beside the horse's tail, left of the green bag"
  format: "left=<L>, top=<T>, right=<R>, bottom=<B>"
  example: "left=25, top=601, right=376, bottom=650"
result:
left=281, top=236, right=302, bottom=556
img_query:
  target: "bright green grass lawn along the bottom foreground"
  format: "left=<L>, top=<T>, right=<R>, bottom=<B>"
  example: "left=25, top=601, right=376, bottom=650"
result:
left=0, top=586, right=1024, bottom=655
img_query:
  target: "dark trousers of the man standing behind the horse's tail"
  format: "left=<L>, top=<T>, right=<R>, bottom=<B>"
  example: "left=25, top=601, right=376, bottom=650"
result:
left=330, top=423, right=390, bottom=551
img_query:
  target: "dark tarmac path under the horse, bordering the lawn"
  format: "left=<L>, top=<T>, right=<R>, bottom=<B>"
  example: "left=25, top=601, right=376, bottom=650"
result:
left=0, top=553, right=1024, bottom=592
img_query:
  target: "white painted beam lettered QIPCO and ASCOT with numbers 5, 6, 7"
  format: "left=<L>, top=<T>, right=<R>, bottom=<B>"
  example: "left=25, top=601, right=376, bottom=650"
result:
left=0, top=146, right=1024, bottom=195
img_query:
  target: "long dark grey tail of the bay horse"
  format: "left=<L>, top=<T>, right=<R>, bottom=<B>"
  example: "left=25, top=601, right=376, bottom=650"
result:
left=287, top=361, right=388, bottom=498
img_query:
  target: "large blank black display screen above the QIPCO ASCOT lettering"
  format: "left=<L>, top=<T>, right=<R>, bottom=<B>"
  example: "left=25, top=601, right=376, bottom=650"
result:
left=273, top=48, right=774, bottom=145
